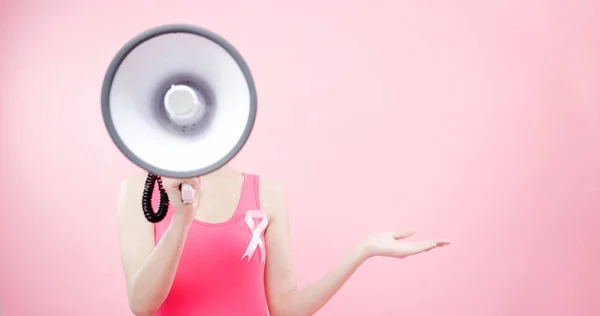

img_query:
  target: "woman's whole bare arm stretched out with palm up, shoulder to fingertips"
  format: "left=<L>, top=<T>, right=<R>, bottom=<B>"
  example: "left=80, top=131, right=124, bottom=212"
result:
left=261, top=183, right=449, bottom=316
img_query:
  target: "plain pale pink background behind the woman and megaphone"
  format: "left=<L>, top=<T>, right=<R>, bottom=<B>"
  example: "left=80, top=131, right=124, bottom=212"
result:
left=0, top=0, right=600, bottom=316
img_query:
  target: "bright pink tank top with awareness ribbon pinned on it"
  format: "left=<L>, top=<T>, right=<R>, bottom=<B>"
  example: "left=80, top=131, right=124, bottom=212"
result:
left=153, top=174, right=268, bottom=316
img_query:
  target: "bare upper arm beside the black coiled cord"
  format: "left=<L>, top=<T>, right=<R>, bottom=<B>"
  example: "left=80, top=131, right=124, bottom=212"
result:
left=117, top=175, right=154, bottom=289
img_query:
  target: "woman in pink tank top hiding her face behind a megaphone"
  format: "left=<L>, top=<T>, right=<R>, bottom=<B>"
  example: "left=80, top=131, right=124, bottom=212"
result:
left=118, top=166, right=449, bottom=316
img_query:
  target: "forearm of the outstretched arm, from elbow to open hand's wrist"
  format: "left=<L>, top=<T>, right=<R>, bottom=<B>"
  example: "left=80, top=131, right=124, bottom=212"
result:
left=272, top=246, right=368, bottom=316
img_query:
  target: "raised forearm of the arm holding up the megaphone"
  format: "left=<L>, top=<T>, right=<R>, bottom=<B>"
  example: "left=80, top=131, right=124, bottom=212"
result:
left=129, top=213, right=191, bottom=316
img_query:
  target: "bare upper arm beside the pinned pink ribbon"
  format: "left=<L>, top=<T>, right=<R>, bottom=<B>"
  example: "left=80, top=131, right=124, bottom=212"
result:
left=260, top=181, right=297, bottom=301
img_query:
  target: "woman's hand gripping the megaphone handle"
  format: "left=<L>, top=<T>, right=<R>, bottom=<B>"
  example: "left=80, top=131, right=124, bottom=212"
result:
left=162, top=177, right=200, bottom=221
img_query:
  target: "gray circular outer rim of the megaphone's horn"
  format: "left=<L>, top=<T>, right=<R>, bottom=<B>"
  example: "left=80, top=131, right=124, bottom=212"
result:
left=101, top=24, right=257, bottom=178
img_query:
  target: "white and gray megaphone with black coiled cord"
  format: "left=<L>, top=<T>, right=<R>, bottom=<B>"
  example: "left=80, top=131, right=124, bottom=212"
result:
left=101, top=24, right=256, bottom=223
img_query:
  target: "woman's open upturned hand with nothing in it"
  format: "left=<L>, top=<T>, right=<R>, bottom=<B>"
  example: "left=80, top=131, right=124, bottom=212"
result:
left=364, top=229, right=450, bottom=258
